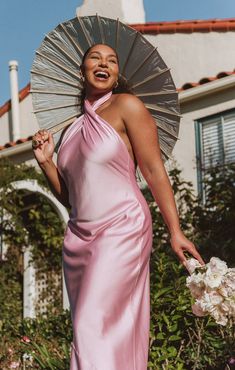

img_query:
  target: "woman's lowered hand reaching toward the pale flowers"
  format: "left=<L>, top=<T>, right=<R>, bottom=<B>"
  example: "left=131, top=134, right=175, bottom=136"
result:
left=171, top=230, right=205, bottom=267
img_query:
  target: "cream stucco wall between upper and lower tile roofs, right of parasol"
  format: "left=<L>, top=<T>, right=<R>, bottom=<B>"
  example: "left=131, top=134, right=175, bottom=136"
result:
left=145, top=32, right=235, bottom=87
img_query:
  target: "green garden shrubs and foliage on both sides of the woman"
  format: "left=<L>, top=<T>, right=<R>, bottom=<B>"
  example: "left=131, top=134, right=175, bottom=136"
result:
left=0, top=160, right=235, bottom=370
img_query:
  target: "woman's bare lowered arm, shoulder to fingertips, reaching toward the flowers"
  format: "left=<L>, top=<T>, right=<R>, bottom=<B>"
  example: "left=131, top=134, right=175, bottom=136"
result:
left=120, top=94, right=204, bottom=265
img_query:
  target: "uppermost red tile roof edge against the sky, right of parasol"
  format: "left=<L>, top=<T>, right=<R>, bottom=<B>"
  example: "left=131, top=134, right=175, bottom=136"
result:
left=131, top=18, right=235, bottom=35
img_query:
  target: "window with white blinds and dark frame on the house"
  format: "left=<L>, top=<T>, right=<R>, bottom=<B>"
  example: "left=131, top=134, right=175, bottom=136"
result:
left=195, top=109, right=235, bottom=195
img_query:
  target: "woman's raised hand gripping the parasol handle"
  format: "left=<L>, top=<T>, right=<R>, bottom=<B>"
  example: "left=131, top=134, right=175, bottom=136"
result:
left=32, top=130, right=55, bottom=165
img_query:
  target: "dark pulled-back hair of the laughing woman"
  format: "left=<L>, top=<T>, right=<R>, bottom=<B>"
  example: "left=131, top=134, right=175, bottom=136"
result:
left=80, top=44, right=133, bottom=113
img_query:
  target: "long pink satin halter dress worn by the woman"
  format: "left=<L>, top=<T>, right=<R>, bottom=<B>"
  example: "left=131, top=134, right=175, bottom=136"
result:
left=58, top=92, right=152, bottom=370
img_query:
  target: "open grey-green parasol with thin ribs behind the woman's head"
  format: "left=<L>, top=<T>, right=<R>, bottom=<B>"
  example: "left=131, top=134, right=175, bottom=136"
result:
left=31, top=15, right=180, bottom=175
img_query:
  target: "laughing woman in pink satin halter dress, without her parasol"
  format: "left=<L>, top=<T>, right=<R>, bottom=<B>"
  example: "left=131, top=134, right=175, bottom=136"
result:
left=34, top=44, right=203, bottom=370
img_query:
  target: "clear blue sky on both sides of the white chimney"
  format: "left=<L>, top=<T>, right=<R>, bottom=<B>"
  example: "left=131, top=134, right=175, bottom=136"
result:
left=0, top=0, right=235, bottom=106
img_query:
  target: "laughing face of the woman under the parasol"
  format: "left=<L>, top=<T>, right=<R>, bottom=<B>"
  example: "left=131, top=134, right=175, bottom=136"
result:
left=81, top=44, right=119, bottom=94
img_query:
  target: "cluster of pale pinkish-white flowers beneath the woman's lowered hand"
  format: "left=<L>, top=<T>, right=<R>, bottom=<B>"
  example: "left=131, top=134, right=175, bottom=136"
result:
left=186, top=257, right=235, bottom=325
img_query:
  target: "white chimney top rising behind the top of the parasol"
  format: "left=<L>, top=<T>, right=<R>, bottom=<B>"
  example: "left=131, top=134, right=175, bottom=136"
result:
left=77, top=0, right=145, bottom=23
